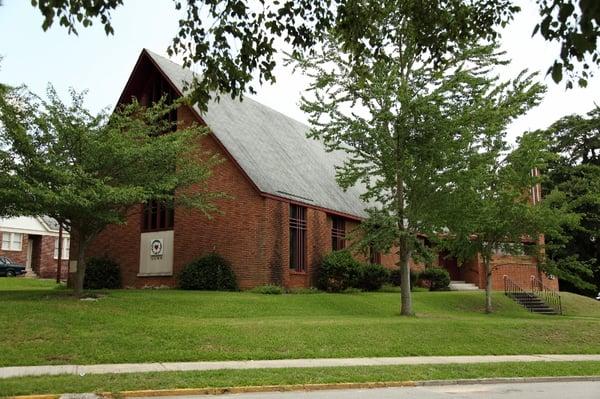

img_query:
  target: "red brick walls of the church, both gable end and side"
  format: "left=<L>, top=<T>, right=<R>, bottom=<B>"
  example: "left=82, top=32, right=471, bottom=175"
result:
left=77, top=67, right=556, bottom=288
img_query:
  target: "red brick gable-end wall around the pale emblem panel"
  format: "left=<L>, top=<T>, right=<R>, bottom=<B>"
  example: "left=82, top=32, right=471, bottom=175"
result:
left=81, top=104, right=276, bottom=288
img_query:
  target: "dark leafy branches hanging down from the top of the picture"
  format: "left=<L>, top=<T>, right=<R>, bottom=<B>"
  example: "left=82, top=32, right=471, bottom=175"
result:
left=27, top=0, right=600, bottom=101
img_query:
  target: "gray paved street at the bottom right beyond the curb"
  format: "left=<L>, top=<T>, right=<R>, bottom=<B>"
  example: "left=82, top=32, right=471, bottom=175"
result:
left=144, top=381, right=600, bottom=399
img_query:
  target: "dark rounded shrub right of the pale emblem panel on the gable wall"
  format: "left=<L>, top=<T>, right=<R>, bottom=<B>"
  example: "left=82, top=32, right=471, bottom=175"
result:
left=179, top=253, right=237, bottom=291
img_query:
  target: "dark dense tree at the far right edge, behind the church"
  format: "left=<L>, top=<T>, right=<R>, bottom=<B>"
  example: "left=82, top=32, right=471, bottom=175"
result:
left=543, top=108, right=600, bottom=295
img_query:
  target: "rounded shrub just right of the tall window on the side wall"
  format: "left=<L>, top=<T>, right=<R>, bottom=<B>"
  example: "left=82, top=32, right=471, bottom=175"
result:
left=316, top=250, right=360, bottom=292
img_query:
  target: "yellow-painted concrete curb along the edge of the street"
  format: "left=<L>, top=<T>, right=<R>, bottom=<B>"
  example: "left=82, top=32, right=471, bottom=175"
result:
left=5, top=376, right=600, bottom=399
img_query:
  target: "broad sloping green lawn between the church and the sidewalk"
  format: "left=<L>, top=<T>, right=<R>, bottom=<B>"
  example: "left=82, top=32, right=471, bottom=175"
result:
left=0, top=278, right=600, bottom=366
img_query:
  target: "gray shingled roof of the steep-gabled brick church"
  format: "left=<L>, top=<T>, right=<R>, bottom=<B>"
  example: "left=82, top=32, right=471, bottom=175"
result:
left=146, top=50, right=365, bottom=218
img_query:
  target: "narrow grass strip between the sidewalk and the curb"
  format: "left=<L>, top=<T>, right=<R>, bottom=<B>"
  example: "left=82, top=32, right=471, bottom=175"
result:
left=0, top=362, right=600, bottom=398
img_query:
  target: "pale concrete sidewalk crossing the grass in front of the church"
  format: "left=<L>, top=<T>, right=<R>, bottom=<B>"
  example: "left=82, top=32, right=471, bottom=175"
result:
left=0, top=355, right=600, bottom=378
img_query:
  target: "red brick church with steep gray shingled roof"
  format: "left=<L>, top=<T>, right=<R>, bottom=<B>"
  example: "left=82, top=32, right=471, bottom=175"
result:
left=77, top=50, right=557, bottom=289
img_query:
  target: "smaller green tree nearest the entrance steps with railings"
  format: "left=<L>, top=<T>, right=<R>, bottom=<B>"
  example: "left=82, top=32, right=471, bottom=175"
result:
left=441, top=133, right=577, bottom=313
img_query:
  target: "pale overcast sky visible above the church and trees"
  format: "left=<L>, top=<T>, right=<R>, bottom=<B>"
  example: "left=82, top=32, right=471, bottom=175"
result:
left=0, top=0, right=600, bottom=144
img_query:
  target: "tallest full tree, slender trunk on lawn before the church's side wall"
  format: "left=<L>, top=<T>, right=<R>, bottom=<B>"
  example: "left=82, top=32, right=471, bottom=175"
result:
left=295, top=20, right=543, bottom=315
